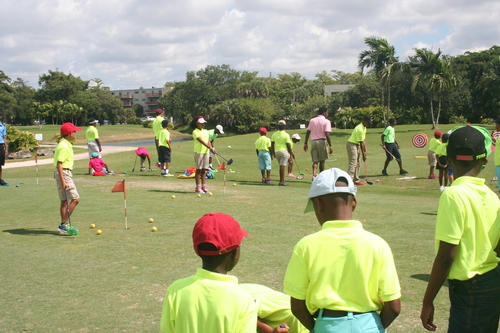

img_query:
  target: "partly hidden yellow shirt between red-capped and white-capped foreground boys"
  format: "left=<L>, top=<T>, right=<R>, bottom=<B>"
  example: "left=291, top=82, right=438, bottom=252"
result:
left=240, top=283, right=309, bottom=333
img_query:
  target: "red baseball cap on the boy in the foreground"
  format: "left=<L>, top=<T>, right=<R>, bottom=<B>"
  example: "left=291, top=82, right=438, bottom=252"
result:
left=193, top=213, right=248, bottom=256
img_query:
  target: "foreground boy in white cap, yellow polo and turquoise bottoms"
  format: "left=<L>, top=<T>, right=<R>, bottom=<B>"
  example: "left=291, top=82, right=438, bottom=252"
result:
left=284, top=168, right=401, bottom=333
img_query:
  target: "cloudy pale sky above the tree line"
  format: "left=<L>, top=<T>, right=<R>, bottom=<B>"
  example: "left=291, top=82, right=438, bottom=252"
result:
left=0, top=0, right=500, bottom=89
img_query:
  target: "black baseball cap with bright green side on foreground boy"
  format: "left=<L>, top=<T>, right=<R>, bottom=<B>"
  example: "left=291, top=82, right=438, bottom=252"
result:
left=446, top=125, right=491, bottom=161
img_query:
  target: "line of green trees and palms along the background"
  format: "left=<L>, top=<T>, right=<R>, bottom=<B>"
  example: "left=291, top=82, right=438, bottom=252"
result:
left=0, top=37, right=500, bottom=133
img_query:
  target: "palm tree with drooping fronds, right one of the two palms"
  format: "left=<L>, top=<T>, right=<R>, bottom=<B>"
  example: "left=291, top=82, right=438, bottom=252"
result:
left=411, top=49, right=458, bottom=129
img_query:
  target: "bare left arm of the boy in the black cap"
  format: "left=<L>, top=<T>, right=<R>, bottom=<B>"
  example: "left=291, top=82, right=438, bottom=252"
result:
left=420, top=241, right=458, bottom=331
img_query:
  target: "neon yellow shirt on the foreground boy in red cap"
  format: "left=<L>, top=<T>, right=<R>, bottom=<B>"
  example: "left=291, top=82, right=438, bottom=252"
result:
left=160, top=268, right=257, bottom=333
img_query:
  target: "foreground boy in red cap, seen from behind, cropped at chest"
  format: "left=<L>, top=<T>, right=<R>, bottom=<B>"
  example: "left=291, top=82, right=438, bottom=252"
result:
left=160, top=213, right=257, bottom=333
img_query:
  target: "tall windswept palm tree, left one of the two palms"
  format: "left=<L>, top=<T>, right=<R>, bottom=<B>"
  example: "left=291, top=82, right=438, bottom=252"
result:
left=358, top=36, right=399, bottom=122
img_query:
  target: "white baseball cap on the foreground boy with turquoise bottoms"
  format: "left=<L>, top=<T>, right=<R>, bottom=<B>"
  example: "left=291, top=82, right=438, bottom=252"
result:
left=304, top=168, right=357, bottom=213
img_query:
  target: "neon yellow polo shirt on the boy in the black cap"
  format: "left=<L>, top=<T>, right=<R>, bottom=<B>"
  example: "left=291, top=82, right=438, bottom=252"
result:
left=436, top=176, right=500, bottom=281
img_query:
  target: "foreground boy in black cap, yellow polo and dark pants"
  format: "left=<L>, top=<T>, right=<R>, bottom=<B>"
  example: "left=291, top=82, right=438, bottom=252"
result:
left=420, top=126, right=500, bottom=333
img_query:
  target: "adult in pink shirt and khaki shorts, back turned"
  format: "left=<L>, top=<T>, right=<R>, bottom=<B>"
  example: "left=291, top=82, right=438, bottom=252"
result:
left=304, top=106, right=333, bottom=179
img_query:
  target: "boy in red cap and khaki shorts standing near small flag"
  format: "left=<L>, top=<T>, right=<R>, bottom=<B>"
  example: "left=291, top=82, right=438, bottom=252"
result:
left=54, top=123, right=82, bottom=234
